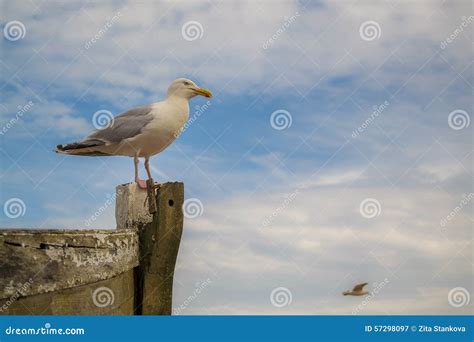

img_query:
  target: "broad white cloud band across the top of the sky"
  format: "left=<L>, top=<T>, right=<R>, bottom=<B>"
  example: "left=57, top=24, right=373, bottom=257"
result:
left=2, top=1, right=469, bottom=116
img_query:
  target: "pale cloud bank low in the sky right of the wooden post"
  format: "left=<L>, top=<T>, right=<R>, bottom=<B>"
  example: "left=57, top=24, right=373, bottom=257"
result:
left=172, top=168, right=472, bottom=314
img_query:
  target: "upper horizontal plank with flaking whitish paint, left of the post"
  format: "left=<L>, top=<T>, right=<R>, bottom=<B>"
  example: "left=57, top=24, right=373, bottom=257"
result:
left=0, top=230, right=138, bottom=299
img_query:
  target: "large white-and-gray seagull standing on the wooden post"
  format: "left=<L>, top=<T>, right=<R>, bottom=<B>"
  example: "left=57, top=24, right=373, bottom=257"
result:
left=56, top=78, right=212, bottom=189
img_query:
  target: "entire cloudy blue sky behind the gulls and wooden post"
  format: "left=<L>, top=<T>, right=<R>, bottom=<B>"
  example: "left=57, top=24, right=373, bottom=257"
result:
left=0, top=0, right=473, bottom=314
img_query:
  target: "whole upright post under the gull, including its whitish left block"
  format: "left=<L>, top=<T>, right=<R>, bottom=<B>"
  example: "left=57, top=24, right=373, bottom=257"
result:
left=117, top=183, right=184, bottom=315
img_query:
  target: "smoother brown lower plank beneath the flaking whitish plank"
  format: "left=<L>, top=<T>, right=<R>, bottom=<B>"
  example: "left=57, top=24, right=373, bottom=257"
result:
left=0, top=270, right=134, bottom=315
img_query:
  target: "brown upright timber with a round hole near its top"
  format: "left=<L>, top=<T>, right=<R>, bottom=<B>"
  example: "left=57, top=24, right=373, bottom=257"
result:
left=135, top=183, right=184, bottom=315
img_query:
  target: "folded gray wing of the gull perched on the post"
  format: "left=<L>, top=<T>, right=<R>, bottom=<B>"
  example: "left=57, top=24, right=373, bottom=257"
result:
left=85, top=106, right=153, bottom=143
